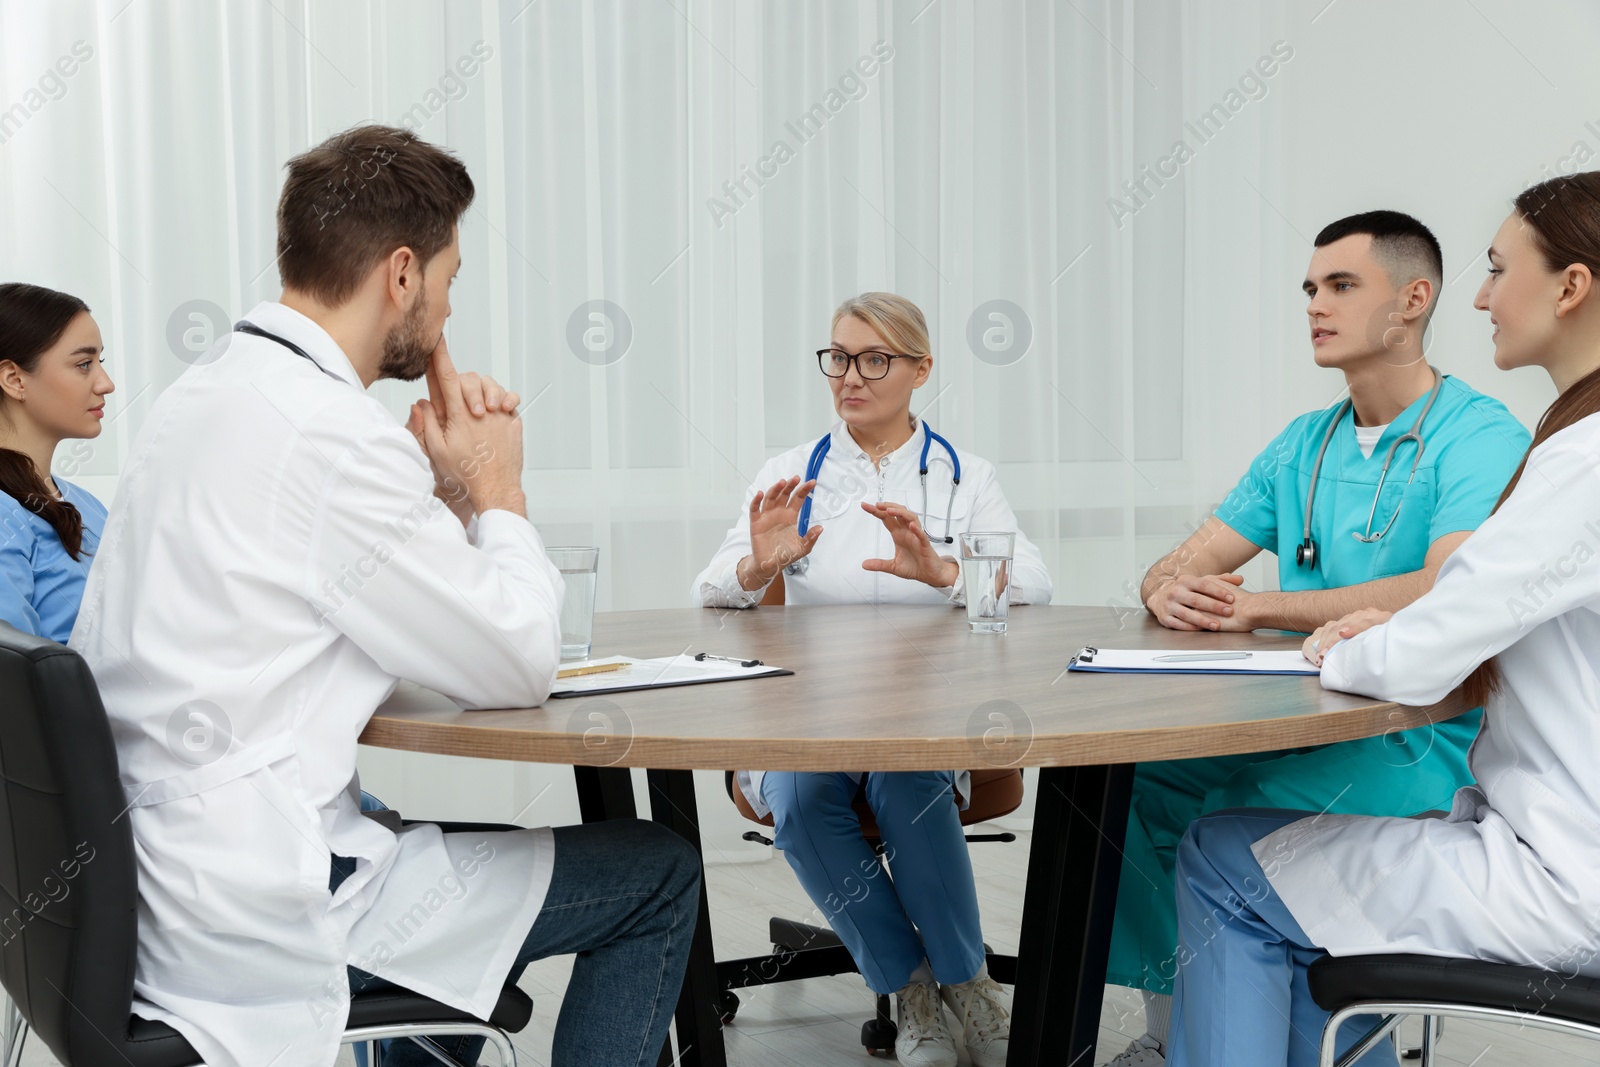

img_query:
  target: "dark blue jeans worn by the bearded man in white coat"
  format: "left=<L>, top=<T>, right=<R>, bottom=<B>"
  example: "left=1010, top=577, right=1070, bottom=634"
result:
left=333, top=819, right=701, bottom=1067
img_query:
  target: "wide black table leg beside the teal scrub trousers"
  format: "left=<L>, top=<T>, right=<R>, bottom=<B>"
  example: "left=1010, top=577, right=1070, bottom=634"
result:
left=1006, top=763, right=1133, bottom=1067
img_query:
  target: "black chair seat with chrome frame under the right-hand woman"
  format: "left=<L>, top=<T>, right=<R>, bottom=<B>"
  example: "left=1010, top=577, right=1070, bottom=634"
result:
left=1307, top=955, right=1600, bottom=1067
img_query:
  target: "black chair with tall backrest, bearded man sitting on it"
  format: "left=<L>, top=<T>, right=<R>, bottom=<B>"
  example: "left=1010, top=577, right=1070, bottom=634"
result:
left=0, top=622, right=533, bottom=1067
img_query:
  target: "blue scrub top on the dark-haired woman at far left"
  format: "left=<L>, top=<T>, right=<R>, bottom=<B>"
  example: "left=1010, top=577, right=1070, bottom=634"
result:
left=0, top=478, right=106, bottom=645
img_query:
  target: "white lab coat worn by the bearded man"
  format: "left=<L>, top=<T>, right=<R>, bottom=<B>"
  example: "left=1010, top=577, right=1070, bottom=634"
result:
left=72, top=304, right=562, bottom=1067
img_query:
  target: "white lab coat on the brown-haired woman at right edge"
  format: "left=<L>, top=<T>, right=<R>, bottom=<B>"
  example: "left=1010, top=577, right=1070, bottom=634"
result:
left=1254, top=414, right=1600, bottom=976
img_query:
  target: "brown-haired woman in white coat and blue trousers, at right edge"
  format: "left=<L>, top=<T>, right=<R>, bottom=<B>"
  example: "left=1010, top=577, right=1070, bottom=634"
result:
left=1166, top=173, right=1600, bottom=1067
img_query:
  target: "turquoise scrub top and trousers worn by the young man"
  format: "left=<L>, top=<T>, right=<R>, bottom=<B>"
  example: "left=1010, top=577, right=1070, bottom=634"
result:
left=1109, top=378, right=1530, bottom=993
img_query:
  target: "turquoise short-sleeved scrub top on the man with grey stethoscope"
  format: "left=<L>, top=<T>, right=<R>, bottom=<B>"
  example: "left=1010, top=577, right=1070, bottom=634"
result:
left=1214, top=376, right=1531, bottom=590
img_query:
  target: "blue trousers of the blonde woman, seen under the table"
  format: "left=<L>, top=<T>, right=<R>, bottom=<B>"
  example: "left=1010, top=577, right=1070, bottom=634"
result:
left=762, top=771, right=984, bottom=993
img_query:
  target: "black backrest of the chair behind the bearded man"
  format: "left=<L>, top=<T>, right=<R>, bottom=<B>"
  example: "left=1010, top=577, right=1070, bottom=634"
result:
left=0, top=622, right=138, bottom=1065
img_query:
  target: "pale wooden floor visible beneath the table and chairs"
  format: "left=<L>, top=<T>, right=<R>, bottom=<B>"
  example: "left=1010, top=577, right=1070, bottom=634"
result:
left=22, top=833, right=1600, bottom=1067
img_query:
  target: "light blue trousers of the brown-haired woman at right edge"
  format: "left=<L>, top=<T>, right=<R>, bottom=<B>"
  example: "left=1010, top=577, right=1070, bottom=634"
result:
left=1166, top=808, right=1394, bottom=1067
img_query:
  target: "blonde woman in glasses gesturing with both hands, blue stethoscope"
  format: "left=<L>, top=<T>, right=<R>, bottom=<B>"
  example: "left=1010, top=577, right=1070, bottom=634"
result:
left=693, top=293, right=1051, bottom=1067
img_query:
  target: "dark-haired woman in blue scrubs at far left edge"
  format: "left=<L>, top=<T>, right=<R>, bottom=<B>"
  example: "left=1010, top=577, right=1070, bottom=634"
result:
left=0, top=283, right=114, bottom=643
